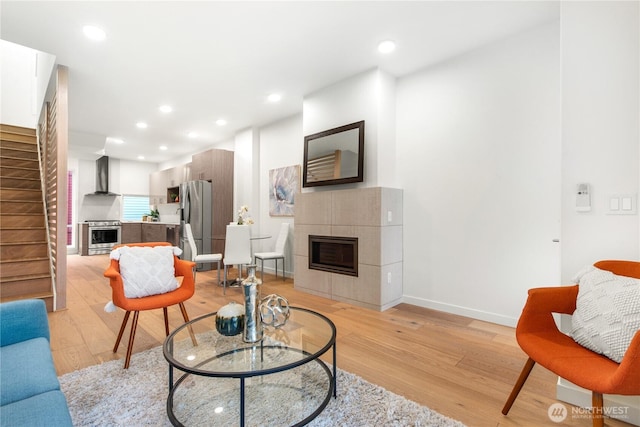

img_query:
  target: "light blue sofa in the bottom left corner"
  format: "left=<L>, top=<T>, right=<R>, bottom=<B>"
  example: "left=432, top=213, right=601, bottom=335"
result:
left=0, top=300, right=73, bottom=427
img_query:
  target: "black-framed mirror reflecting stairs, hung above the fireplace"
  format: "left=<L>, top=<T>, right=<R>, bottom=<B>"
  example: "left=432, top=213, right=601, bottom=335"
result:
left=302, top=120, right=364, bottom=187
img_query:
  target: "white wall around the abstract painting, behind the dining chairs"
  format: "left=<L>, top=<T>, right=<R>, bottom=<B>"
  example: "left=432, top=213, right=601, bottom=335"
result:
left=257, top=114, right=304, bottom=276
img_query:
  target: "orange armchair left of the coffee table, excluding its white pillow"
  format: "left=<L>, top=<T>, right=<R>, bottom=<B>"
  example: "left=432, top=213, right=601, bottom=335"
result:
left=104, top=242, right=197, bottom=369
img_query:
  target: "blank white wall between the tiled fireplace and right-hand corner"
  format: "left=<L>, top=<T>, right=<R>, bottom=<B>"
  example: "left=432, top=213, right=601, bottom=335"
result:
left=396, top=22, right=560, bottom=325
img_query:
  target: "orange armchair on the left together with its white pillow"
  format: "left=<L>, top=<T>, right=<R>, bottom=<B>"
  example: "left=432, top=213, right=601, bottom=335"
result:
left=104, top=242, right=197, bottom=369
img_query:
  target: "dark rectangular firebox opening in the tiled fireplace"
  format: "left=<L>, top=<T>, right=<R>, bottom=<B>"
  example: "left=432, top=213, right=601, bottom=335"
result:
left=309, top=235, right=358, bottom=277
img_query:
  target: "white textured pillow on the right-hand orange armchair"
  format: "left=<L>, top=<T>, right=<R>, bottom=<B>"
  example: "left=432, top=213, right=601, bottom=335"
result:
left=571, top=267, right=640, bottom=363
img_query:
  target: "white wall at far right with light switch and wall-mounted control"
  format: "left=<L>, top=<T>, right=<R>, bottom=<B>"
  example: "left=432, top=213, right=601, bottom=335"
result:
left=558, top=1, right=640, bottom=425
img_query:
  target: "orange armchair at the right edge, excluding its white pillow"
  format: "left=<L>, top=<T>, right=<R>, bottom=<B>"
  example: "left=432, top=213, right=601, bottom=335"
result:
left=502, top=261, right=640, bottom=427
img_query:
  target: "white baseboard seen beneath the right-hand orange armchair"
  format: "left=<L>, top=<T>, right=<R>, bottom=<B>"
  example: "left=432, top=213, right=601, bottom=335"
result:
left=556, top=378, right=640, bottom=426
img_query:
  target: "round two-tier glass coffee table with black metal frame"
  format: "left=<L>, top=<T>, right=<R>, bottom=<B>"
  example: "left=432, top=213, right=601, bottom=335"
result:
left=163, top=307, right=337, bottom=426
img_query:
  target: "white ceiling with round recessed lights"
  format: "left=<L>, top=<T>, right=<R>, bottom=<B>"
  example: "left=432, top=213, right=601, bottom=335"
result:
left=0, top=0, right=559, bottom=163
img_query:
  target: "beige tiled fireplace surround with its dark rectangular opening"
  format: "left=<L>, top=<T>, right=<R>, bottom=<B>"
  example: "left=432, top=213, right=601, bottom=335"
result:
left=294, top=187, right=402, bottom=310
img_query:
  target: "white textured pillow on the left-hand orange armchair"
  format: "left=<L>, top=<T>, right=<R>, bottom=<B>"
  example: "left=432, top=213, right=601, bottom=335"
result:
left=112, top=246, right=178, bottom=298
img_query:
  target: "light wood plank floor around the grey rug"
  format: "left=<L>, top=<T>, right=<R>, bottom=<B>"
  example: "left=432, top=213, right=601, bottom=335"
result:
left=49, top=255, right=629, bottom=427
